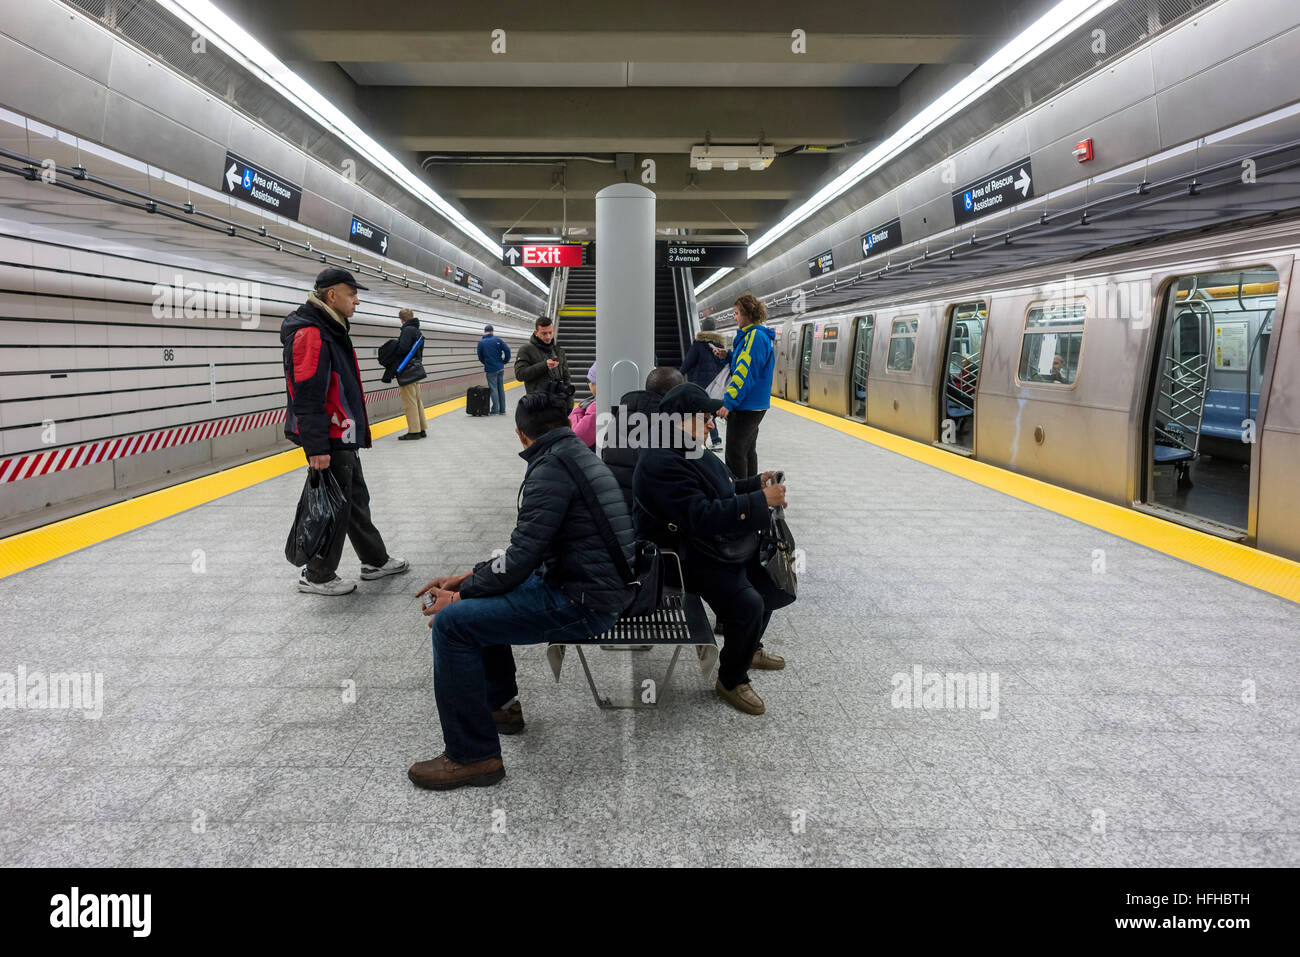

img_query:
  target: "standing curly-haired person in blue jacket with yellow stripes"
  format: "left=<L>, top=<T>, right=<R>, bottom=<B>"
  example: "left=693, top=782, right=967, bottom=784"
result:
left=718, top=293, right=776, bottom=479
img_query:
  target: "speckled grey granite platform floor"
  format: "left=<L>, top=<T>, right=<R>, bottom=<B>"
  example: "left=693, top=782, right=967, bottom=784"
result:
left=0, top=391, right=1300, bottom=866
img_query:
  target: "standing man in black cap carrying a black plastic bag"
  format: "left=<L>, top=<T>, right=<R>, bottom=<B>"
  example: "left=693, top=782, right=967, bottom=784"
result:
left=280, top=267, right=411, bottom=594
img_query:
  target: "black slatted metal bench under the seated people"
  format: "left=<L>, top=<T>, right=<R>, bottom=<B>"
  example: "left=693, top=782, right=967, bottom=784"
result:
left=546, top=551, right=718, bottom=710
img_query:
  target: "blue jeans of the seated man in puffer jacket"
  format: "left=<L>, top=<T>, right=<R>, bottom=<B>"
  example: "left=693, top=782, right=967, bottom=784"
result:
left=432, top=571, right=619, bottom=765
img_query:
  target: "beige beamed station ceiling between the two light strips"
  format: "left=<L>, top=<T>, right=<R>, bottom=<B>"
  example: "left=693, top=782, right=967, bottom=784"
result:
left=208, top=0, right=1053, bottom=243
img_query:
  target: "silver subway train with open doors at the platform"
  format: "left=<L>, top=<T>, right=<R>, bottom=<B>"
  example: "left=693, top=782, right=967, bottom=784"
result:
left=768, top=221, right=1300, bottom=559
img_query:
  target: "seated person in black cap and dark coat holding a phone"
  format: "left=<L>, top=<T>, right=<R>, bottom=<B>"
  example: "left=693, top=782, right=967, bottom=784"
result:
left=632, top=382, right=789, bottom=714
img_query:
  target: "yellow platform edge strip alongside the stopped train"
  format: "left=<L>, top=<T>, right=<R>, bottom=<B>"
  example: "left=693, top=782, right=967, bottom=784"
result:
left=772, top=397, right=1300, bottom=602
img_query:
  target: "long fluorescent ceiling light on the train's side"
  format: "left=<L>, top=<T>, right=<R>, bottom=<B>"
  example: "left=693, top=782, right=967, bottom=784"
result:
left=694, top=0, right=1117, bottom=295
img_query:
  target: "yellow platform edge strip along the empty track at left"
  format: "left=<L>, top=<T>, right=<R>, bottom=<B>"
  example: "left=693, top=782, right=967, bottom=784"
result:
left=0, top=382, right=521, bottom=579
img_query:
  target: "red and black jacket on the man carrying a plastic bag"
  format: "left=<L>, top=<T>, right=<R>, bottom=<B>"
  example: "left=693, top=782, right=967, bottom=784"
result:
left=280, top=300, right=371, bottom=455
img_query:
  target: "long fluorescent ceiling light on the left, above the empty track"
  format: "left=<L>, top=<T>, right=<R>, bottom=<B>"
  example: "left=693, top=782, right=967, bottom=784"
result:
left=159, top=0, right=550, bottom=293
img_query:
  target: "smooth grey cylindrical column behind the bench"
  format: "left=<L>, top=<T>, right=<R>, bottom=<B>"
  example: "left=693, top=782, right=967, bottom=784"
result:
left=595, top=183, right=655, bottom=410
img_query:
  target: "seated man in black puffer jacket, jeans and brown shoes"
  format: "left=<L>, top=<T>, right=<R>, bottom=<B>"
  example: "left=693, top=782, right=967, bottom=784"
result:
left=407, top=393, right=636, bottom=791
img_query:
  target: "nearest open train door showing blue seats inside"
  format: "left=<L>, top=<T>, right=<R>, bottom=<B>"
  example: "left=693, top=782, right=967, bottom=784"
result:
left=1139, top=267, right=1278, bottom=541
